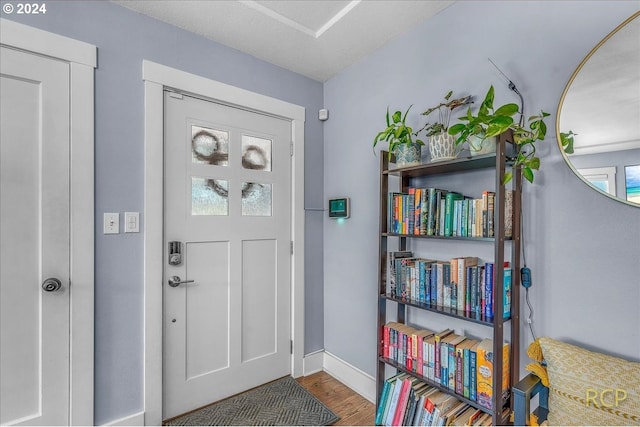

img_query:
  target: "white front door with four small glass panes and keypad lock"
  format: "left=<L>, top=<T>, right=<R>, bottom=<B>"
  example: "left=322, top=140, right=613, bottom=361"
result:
left=163, top=92, right=291, bottom=418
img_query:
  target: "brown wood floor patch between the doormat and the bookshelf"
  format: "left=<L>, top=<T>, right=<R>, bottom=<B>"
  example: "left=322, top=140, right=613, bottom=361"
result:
left=297, top=372, right=376, bottom=426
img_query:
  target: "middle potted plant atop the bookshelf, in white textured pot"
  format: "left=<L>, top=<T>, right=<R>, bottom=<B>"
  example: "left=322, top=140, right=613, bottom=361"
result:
left=416, top=91, right=472, bottom=161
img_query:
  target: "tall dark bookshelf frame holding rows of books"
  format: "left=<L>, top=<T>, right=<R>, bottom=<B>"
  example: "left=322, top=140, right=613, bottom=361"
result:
left=376, top=134, right=522, bottom=425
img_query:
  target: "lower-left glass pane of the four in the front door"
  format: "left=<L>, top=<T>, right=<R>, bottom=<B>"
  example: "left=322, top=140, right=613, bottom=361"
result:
left=191, top=177, right=229, bottom=215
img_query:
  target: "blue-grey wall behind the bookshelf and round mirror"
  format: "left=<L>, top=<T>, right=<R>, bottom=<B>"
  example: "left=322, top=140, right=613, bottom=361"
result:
left=324, top=1, right=640, bottom=382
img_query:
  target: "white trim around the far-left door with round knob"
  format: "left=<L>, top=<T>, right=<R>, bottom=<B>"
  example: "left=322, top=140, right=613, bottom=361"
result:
left=0, top=19, right=97, bottom=425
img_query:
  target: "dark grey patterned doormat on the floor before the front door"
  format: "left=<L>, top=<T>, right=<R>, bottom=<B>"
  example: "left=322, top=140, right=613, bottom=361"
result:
left=164, top=377, right=339, bottom=426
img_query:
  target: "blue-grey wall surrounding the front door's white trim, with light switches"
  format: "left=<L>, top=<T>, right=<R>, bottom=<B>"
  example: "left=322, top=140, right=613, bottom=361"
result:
left=3, top=1, right=324, bottom=424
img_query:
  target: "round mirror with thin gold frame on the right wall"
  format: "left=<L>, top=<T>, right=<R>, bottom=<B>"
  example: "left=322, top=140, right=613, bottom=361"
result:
left=556, top=12, right=640, bottom=206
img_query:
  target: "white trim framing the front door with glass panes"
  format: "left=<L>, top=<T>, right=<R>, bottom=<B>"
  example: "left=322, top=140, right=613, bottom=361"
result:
left=142, top=60, right=305, bottom=425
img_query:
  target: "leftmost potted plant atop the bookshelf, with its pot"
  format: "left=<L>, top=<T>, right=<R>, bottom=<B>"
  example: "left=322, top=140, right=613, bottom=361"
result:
left=373, top=105, right=424, bottom=166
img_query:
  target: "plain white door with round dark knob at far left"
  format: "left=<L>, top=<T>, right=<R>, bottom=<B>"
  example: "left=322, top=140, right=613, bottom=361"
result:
left=0, top=47, right=70, bottom=425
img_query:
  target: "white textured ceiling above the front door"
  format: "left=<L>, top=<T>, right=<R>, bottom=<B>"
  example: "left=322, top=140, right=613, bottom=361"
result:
left=114, top=0, right=453, bottom=82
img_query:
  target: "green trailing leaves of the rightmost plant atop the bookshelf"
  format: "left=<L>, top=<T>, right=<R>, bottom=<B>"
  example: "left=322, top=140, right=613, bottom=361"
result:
left=448, top=86, right=549, bottom=184
